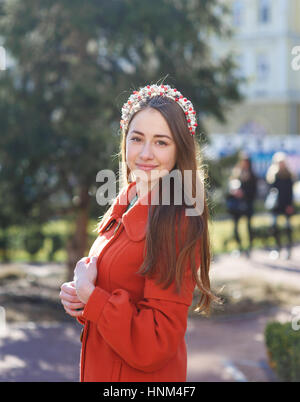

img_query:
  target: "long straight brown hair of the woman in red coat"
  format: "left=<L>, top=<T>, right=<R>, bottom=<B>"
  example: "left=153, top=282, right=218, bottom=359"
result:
left=100, top=96, right=219, bottom=313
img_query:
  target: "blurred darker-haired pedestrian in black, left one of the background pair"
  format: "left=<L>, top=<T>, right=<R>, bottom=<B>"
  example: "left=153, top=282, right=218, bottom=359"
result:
left=226, top=152, right=257, bottom=256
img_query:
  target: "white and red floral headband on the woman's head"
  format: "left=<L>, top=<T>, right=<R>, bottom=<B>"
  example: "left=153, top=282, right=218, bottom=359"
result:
left=120, top=85, right=198, bottom=135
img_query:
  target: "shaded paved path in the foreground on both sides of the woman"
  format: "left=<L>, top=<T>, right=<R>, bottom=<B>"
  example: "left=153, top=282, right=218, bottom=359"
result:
left=0, top=313, right=286, bottom=382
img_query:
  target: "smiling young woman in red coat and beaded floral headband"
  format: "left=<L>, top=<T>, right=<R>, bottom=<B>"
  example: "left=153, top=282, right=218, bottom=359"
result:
left=60, top=85, right=217, bottom=382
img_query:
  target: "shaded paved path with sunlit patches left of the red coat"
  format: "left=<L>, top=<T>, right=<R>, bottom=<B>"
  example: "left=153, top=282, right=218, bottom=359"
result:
left=0, top=322, right=80, bottom=381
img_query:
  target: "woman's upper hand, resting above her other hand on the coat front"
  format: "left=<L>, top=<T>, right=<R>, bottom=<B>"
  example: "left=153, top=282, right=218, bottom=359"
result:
left=74, top=257, right=98, bottom=304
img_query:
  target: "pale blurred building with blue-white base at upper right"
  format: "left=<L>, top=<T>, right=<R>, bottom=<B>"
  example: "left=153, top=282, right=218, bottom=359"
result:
left=204, top=0, right=300, bottom=176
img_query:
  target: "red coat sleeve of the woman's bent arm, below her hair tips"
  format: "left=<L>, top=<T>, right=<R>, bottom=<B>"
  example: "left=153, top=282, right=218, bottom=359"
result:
left=83, top=250, right=195, bottom=372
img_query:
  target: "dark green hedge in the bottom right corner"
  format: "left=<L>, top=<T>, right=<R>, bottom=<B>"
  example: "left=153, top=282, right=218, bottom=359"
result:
left=265, top=321, right=300, bottom=382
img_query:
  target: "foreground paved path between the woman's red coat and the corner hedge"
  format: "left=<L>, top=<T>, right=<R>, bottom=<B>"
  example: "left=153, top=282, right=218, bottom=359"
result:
left=186, top=311, right=285, bottom=382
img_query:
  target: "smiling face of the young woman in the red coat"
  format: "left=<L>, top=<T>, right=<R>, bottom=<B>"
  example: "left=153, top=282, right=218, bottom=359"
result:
left=126, top=108, right=176, bottom=182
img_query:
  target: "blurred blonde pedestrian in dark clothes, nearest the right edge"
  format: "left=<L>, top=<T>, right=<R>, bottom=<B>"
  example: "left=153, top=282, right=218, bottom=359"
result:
left=265, top=152, right=294, bottom=258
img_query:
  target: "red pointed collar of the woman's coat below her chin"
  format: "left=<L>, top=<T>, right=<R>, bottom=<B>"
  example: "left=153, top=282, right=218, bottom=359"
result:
left=99, top=181, right=155, bottom=241
